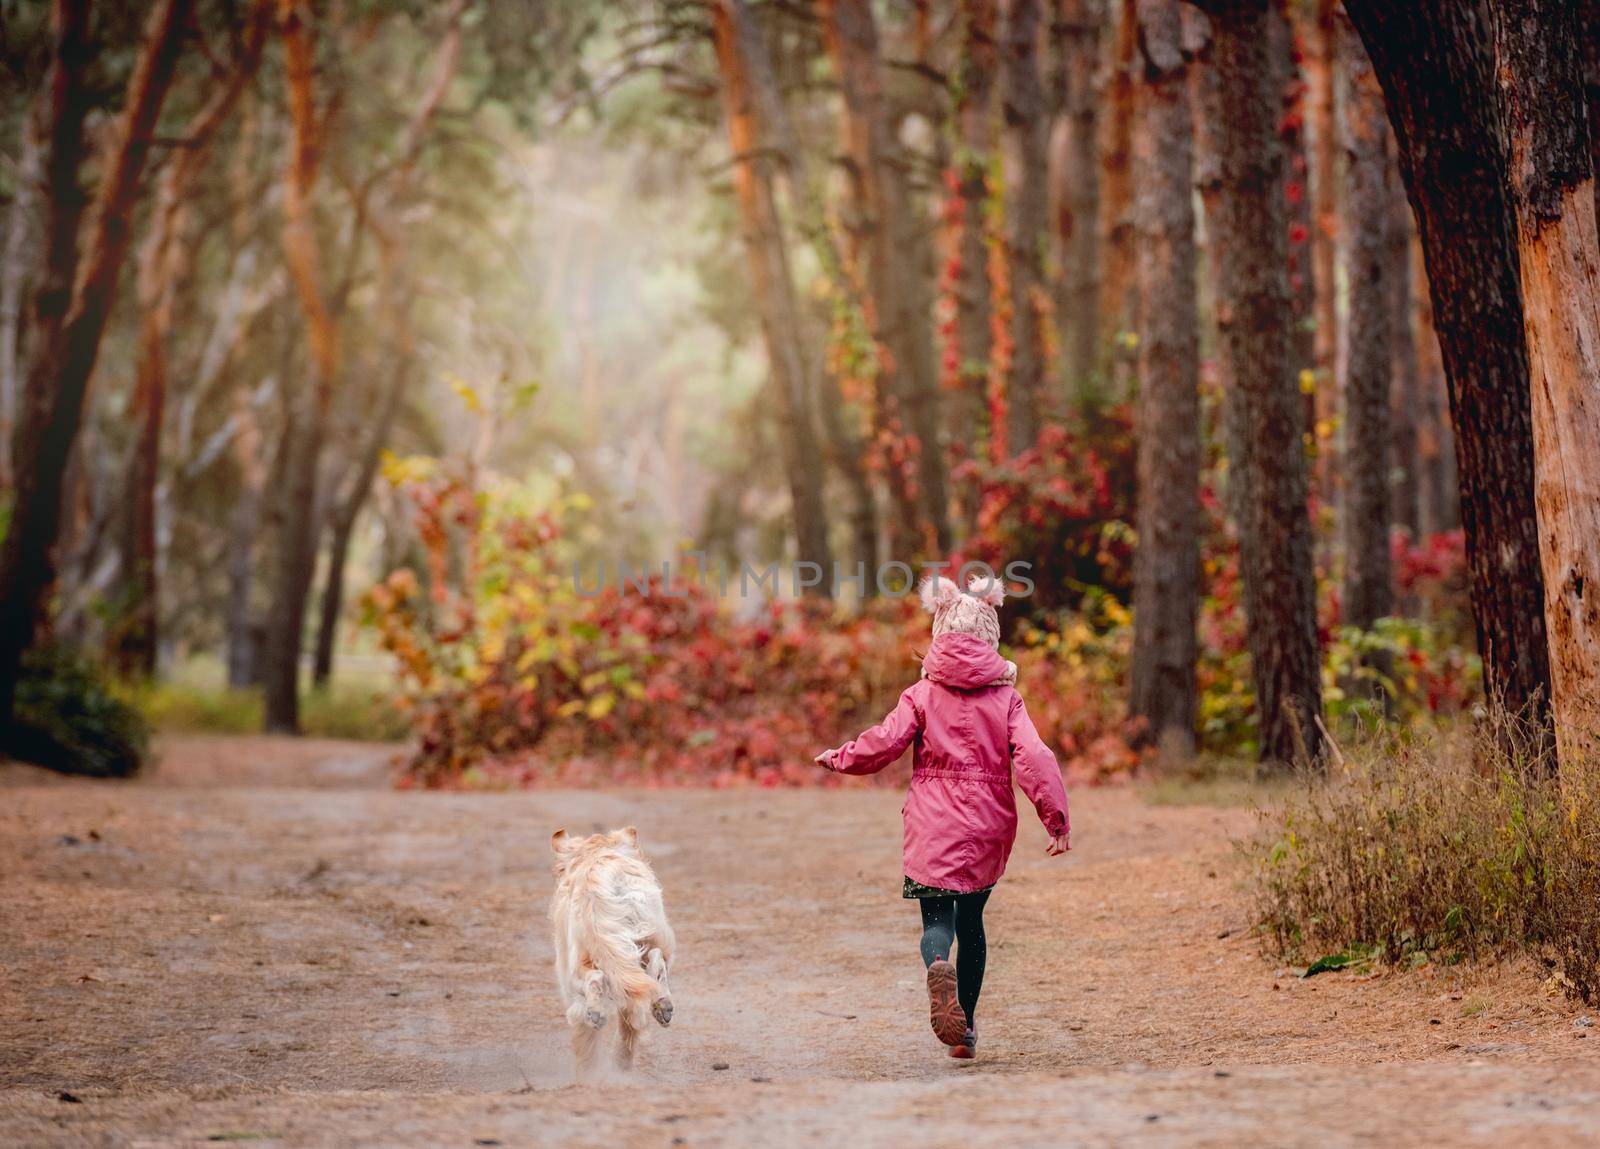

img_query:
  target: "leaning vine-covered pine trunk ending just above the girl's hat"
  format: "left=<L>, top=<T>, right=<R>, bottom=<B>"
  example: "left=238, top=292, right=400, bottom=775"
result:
left=822, top=0, right=950, bottom=557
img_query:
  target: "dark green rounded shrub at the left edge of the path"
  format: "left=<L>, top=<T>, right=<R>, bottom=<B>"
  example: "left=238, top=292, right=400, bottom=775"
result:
left=5, top=648, right=150, bottom=778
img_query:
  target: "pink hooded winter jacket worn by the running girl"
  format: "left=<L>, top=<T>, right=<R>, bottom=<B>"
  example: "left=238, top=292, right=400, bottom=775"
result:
left=826, top=634, right=1067, bottom=893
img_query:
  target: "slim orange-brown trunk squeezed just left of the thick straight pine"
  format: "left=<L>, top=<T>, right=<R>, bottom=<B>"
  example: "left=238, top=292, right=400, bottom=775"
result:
left=1099, top=0, right=1139, bottom=377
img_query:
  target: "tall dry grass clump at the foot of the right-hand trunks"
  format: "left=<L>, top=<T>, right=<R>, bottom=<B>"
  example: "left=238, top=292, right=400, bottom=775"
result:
left=1246, top=715, right=1600, bottom=1000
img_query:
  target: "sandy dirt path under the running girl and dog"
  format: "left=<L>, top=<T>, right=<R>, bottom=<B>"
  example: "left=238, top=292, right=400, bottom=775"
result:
left=0, top=739, right=1600, bottom=1149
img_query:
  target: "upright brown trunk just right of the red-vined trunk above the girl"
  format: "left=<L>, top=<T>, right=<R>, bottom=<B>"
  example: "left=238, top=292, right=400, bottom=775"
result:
left=1000, top=0, right=1050, bottom=456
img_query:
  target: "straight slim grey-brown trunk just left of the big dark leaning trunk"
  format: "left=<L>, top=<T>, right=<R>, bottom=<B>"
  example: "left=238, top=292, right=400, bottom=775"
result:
left=1339, top=13, right=1395, bottom=631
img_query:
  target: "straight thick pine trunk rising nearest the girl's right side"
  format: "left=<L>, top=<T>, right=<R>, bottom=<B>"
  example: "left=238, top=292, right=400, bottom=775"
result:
left=1130, top=0, right=1200, bottom=754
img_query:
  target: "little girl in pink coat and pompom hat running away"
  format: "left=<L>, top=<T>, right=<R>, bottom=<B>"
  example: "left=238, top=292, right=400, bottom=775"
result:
left=816, top=576, right=1069, bottom=1058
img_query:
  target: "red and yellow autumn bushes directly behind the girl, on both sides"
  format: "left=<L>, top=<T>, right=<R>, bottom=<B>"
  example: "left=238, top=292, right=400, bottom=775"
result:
left=365, top=467, right=1134, bottom=787
